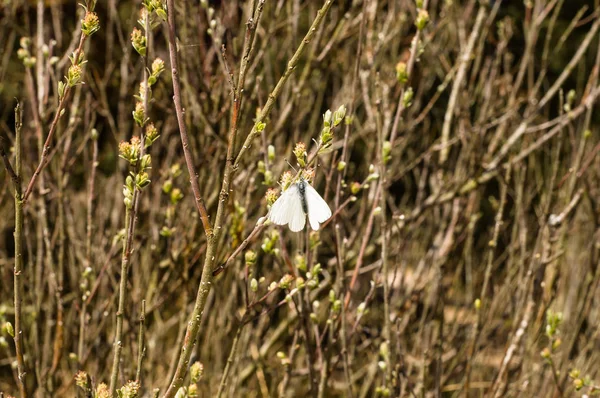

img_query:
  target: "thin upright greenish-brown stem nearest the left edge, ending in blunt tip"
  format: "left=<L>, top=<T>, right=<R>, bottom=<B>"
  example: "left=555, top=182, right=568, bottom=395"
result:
left=14, top=103, right=27, bottom=398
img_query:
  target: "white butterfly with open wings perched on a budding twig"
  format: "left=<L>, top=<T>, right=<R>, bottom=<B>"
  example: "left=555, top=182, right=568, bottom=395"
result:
left=269, top=179, right=331, bottom=232
